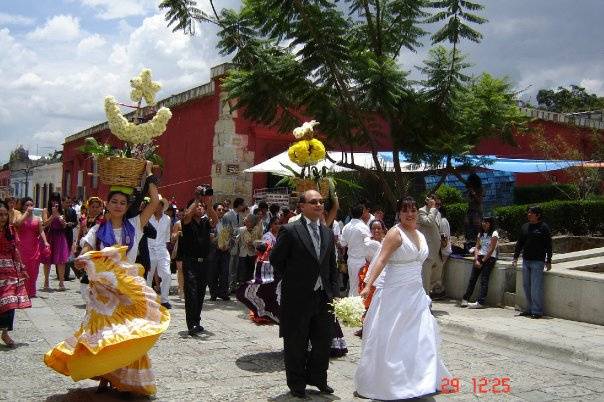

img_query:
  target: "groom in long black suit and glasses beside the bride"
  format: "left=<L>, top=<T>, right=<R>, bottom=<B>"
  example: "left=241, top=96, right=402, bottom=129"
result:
left=270, top=190, right=338, bottom=398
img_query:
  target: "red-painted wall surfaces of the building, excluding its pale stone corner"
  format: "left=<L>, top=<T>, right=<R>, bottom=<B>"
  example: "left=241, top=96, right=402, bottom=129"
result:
left=63, top=74, right=591, bottom=207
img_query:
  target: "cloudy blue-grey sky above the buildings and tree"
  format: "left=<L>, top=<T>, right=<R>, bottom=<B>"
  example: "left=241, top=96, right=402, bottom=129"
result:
left=0, top=0, right=604, bottom=162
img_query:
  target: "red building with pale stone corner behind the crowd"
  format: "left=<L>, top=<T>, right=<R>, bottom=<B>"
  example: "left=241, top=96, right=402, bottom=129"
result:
left=63, top=64, right=604, bottom=206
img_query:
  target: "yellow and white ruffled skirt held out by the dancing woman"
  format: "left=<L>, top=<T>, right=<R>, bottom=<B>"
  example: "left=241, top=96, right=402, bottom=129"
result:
left=44, top=247, right=170, bottom=395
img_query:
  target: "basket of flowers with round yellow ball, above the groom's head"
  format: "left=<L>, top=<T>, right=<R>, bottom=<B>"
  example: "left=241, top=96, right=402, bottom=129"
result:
left=279, top=120, right=334, bottom=197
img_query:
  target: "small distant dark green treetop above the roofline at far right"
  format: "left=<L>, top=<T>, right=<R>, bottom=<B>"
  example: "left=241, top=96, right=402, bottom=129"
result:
left=537, top=85, right=604, bottom=113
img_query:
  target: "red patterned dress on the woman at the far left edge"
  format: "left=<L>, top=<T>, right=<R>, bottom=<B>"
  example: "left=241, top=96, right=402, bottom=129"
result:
left=0, top=226, right=31, bottom=331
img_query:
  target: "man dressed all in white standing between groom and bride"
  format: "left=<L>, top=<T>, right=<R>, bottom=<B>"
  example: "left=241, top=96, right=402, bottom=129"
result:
left=340, top=204, right=371, bottom=297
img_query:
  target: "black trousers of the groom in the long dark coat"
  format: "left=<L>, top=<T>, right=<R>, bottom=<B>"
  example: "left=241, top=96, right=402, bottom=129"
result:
left=283, top=290, right=334, bottom=391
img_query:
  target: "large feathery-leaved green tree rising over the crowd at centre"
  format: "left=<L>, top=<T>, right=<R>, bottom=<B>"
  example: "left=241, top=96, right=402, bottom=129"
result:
left=160, top=0, right=520, bottom=203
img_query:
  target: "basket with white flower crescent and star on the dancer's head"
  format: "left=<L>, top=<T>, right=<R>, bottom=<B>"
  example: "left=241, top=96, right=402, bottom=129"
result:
left=80, top=69, right=172, bottom=193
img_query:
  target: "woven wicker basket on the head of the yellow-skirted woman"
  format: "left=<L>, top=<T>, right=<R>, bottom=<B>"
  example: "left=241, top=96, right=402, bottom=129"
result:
left=99, top=157, right=147, bottom=187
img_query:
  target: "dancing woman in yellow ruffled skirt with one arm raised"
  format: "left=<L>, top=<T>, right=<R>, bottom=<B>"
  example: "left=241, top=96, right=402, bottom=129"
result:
left=44, top=166, right=170, bottom=395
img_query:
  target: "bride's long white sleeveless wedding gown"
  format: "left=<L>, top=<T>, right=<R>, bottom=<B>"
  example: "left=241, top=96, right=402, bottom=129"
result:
left=355, top=225, right=450, bottom=400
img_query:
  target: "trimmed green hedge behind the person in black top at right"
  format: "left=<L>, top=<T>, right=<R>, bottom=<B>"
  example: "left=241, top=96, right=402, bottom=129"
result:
left=494, top=199, right=604, bottom=240
